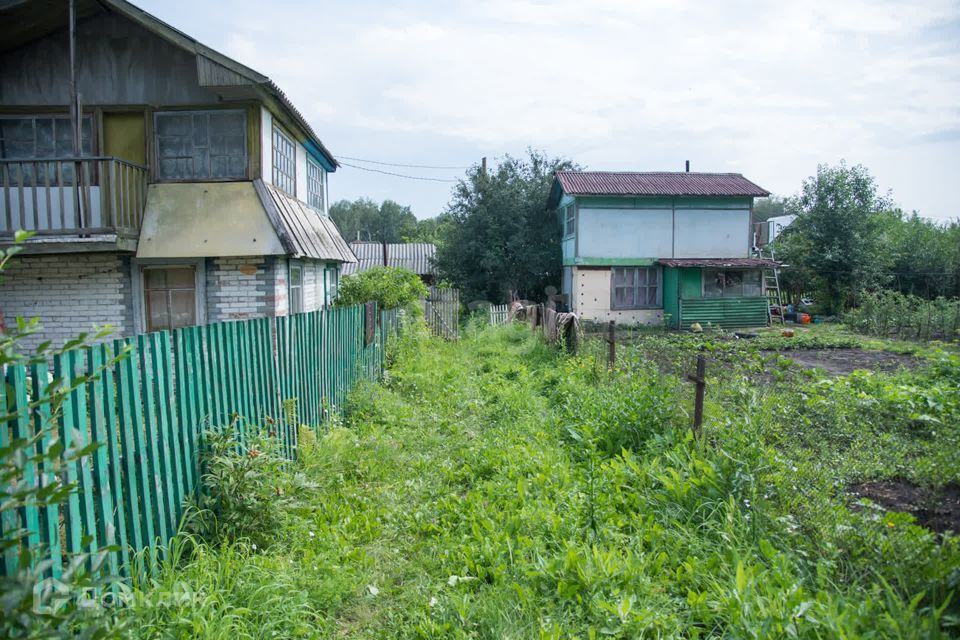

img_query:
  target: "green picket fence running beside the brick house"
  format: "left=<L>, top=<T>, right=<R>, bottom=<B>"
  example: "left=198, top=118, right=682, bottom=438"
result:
left=0, top=305, right=399, bottom=578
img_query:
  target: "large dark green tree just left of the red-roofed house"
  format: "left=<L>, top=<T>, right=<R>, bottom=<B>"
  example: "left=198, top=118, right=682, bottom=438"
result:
left=436, top=149, right=574, bottom=302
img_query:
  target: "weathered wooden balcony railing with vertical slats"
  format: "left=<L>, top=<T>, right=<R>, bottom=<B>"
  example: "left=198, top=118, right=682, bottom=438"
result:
left=0, top=156, right=147, bottom=238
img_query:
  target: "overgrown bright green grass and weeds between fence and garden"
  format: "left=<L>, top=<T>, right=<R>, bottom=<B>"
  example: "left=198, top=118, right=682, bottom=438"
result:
left=116, top=326, right=960, bottom=639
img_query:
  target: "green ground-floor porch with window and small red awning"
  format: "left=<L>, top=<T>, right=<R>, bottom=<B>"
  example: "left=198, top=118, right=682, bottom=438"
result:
left=661, top=261, right=769, bottom=329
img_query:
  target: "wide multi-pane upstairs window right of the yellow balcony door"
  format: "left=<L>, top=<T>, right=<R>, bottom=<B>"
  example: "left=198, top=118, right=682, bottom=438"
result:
left=154, top=110, right=247, bottom=181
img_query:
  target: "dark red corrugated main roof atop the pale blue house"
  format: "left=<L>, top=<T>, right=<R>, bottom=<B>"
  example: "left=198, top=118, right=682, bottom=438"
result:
left=557, top=171, right=770, bottom=198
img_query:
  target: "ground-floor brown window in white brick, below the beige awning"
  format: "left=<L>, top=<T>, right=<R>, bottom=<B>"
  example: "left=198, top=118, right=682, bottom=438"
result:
left=143, top=265, right=197, bottom=331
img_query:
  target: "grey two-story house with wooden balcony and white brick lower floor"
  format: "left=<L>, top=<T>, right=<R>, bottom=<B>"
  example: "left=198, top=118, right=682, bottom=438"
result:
left=0, top=0, right=355, bottom=350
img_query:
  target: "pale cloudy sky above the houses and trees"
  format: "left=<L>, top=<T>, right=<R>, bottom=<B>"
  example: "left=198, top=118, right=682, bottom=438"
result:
left=141, top=0, right=960, bottom=220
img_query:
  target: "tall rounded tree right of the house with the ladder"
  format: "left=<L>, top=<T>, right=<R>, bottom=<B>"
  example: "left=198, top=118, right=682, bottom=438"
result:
left=775, top=161, right=891, bottom=313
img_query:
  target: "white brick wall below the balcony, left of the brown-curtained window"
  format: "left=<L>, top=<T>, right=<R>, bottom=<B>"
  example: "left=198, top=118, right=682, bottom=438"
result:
left=0, top=253, right=133, bottom=349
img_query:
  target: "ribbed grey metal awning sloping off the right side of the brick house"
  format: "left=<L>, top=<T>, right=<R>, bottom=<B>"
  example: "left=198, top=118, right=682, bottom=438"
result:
left=253, top=179, right=357, bottom=264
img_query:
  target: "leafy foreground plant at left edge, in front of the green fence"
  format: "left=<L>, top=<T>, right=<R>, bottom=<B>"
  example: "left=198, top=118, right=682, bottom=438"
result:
left=0, top=232, right=125, bottom=638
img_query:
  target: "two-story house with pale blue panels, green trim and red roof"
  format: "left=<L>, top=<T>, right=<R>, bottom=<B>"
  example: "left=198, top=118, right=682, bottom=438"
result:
left=547, top=171, right=775, bottom=328
